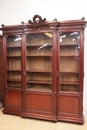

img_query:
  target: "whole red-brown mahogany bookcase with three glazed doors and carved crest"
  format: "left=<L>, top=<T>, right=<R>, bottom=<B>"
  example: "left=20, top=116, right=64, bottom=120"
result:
left=0, top=15, right=86, bottom=124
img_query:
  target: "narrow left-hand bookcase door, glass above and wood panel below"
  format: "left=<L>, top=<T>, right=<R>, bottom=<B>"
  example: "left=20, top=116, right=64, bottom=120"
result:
left=4, top=35, right=22, bottom=113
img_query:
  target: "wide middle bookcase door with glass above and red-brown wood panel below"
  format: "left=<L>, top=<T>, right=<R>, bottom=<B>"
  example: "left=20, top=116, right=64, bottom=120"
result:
left=23, top=33, right=56, bottom=120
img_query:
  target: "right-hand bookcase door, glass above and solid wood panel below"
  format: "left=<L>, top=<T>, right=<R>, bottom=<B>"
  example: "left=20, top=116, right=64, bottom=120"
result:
left=57, top=31, right=81, bottom=120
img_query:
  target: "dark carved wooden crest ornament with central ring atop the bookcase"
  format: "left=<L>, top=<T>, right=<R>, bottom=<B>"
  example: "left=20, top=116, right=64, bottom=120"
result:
left=28, top=15, right=49, bottom=29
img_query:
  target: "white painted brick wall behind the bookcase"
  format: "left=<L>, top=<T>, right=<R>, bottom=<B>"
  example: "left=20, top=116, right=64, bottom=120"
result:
left=0, top=0, right=87, bottom=118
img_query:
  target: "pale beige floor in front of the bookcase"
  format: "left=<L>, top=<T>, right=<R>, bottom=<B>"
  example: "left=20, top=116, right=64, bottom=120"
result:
left=0, top=102, right=87, bottom=130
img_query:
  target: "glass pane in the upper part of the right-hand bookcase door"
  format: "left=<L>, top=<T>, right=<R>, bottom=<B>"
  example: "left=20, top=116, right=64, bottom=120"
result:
left=60, top=32, right=80, bottom=92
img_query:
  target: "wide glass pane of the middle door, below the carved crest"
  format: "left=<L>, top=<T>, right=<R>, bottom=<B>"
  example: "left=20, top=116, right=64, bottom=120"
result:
left=26, top=33, right=52, bottom=92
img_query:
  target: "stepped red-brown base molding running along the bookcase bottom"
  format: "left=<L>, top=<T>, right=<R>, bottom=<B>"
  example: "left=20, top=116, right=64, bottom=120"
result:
left=3, top=108, right=84, bottom=125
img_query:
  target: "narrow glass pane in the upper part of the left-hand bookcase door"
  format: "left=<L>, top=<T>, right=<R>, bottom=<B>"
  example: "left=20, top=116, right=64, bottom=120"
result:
left=7, top=35, right=21, bottom=88
